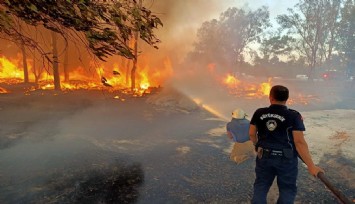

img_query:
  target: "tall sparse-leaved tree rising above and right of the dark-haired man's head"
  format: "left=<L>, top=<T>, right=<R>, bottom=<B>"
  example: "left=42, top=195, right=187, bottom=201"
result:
left=277, top=0, right=341, bottom=73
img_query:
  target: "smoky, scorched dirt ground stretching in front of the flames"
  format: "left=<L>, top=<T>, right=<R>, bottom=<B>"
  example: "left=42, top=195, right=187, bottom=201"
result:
left=0, top=85, right=355, bottom=204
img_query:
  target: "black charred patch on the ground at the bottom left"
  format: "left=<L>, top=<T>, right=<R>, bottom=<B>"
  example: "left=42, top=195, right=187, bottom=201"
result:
left=71, top=164, right=144, bottom=203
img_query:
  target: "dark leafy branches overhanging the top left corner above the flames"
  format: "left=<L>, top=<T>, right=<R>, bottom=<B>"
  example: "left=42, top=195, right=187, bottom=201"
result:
left=0, top=0, right=162, bottom=60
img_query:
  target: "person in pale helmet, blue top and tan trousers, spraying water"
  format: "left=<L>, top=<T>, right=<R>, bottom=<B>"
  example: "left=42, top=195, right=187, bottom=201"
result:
left=226, top=108, right=255, bottom=164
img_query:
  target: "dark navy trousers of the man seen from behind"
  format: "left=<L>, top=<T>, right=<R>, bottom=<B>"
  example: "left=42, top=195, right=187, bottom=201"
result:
left=252, top=156, right=298, bottom=204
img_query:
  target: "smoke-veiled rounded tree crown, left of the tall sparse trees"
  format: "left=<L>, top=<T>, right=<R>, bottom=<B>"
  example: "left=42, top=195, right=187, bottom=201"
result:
left=191, top=7, right=270, bottom=71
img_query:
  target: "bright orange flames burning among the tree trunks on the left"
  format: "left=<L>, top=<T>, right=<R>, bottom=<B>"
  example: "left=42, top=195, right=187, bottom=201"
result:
left=0, top=56, right=173, bottom=95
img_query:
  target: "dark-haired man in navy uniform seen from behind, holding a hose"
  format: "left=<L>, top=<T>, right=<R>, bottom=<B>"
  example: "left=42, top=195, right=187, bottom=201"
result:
left=249, top=85, right=324, bottom=203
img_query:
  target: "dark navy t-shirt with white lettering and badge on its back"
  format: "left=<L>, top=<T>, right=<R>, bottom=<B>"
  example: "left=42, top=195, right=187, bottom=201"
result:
left=250, top=104, right=305, bottom=149
